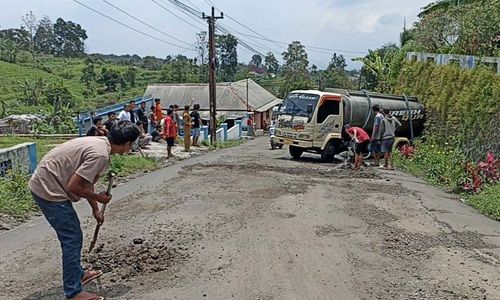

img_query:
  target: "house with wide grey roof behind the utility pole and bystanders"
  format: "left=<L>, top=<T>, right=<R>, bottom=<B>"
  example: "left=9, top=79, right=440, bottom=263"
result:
left=143, top=79, right=282, bottom=129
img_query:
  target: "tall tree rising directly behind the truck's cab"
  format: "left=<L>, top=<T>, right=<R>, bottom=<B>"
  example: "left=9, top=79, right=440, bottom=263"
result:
left=280, top=41, right=313, bottom=97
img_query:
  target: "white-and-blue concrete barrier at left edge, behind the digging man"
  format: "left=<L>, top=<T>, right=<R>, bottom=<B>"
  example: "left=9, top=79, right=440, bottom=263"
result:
left=0, top=143, right=37, bottom=176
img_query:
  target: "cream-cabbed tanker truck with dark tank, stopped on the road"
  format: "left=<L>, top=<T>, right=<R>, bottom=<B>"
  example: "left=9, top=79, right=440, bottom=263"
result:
left=275, top=88, right=425, bottom=162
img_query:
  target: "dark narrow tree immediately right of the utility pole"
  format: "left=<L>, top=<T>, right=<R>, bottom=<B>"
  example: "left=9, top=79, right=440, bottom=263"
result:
left=216, top=34, right=238, bottom=82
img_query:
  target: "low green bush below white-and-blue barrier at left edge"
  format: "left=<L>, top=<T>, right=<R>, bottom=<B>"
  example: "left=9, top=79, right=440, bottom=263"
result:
left=0, top=172, right=37, bottom=218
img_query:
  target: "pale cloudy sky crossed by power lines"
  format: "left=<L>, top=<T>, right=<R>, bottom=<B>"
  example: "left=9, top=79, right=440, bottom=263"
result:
left=0, top=0, right=431, bottom=68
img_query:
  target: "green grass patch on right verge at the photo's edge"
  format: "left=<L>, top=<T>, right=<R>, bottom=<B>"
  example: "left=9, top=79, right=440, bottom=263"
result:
left=466, top=183, right=500, bottom=221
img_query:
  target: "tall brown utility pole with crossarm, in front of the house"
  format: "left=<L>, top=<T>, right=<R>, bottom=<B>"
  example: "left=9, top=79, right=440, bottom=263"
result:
left=203, top=6, right=224, bottom=145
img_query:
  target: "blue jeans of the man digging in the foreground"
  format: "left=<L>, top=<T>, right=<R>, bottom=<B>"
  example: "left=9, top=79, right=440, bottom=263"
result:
left=31, top=193, right=83, bottom=299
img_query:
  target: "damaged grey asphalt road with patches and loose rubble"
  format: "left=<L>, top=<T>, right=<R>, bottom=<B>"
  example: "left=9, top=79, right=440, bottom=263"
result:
left=0, top=138, right=500, bottom=300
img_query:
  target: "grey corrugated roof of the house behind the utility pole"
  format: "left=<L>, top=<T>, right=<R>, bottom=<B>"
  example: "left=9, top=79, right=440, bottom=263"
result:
left=144, top=79, right=280, bottom=111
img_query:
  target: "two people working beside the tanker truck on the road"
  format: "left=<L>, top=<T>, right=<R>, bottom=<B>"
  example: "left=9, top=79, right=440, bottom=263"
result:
left=344, top=104, right=401, bottom=170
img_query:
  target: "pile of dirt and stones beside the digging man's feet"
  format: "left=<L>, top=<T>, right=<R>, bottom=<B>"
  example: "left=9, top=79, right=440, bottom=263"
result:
left=83, top=238, right=189, bottom=281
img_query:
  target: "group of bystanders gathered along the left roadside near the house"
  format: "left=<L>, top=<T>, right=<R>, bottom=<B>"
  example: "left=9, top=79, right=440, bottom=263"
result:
left=86, top=98, right=202, bottom=158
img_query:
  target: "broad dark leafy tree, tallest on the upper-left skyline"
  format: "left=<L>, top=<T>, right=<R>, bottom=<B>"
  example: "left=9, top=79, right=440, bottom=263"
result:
left=54, top=18, right=87, bottom=57
